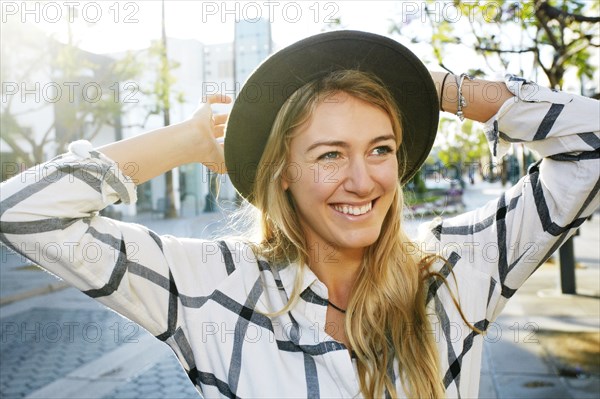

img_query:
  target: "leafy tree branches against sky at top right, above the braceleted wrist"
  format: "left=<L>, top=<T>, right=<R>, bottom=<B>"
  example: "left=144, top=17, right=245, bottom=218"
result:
left=392, top=0, right=600, bottom=91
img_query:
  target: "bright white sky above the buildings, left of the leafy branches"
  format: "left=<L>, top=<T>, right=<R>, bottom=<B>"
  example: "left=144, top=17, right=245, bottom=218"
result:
left=2, top=0, right=401, bottom=53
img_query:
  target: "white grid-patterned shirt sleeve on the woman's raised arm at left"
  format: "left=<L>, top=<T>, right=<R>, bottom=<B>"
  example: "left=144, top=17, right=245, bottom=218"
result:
left=0, top=141, right=239, bottom=340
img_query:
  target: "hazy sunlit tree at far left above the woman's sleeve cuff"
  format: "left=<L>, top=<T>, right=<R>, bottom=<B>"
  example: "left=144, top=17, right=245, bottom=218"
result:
left=0, top=19, right=139, bottom=167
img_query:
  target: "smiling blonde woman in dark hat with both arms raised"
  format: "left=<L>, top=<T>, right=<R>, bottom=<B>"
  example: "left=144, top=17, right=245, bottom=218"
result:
left=0, top=31, right=600, bottom=397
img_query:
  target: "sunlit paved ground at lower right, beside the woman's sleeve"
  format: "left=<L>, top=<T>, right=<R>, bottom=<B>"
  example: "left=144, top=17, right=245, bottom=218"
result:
left=480, top=214, right=600, bottom=398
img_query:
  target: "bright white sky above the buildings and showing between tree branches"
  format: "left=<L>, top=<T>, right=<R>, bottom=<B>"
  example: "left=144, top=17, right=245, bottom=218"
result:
left=0, top=0, right=598, bottom=90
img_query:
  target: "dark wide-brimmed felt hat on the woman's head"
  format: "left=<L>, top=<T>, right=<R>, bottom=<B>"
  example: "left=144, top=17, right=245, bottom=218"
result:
left=225, top=30, right=439, bottom=202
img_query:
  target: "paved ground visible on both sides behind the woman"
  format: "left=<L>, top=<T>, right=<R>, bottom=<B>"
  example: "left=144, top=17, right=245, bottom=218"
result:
left=0, top=183, right=600, bottom=399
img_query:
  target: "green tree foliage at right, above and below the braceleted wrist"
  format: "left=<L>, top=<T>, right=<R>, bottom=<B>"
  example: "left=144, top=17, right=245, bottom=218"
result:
left=390, top=0, right=600, bottom=169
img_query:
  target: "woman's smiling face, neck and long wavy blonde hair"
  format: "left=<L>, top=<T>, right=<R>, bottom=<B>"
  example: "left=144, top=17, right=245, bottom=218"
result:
left=254, top=70, right=442, bottom=397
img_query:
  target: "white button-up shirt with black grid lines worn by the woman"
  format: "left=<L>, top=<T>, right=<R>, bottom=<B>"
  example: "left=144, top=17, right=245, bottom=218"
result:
left=0, top=76, right=600, bottom=398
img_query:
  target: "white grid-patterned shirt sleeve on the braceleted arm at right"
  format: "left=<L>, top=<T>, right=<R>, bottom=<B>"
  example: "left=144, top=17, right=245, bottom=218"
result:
left=421, top=75, right=600, bottom=322
